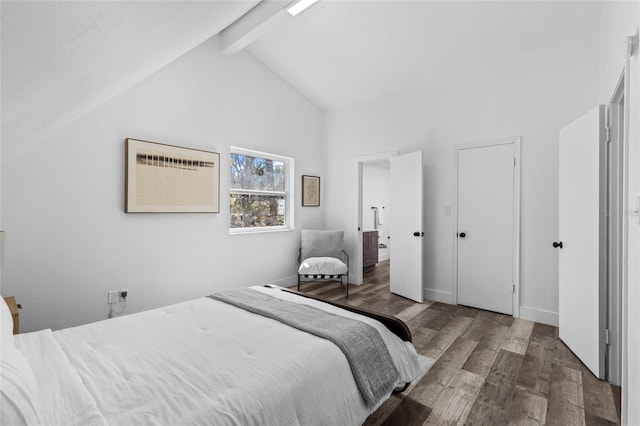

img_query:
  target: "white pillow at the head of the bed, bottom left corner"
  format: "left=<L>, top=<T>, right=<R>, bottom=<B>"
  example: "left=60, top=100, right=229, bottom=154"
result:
left=0, top=342, right=40, bottom=426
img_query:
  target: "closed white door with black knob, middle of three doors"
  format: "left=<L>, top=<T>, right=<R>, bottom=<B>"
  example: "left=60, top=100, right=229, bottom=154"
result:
left=456, top=142, right=515, bottom=315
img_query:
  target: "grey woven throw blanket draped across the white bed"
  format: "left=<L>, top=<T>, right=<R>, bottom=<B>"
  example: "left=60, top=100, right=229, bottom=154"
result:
left=209, top=288, right=399, bottom=409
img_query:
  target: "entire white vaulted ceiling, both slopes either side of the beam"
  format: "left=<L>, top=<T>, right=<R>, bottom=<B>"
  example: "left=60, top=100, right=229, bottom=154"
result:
left=1, top=0, right=601, bottom=155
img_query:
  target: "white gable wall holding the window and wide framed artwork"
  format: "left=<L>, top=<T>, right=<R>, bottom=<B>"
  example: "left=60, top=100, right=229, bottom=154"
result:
left=2, top=38, right=323, bottom=331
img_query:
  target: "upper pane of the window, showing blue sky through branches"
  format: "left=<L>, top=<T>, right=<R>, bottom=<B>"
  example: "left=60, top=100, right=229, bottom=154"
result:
left=231, top=153, right=286, bottom=192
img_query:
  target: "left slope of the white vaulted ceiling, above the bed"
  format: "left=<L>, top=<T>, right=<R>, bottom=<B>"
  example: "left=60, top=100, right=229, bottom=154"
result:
left=0, top=0, right=260, bottom=157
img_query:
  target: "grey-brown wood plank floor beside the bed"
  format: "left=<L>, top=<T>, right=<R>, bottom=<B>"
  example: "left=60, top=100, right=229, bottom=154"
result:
left=301, top=262, right=620, bottom=426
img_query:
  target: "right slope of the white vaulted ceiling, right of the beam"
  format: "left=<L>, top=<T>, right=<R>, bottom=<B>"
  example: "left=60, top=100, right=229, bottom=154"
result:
left=248, top=0, right=601, bottom=108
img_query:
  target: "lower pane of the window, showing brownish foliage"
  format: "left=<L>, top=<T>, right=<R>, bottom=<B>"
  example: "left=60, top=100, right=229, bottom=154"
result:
left=230, top=194, right=285, bottom=228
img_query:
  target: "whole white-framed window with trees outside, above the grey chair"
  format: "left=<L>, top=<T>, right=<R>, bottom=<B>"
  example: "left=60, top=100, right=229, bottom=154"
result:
left=229, top=147, right=293, bottom=233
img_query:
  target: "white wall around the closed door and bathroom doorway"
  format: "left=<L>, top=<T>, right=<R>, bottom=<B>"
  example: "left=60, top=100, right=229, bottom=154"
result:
left=325, top=36, right=597, bottom=324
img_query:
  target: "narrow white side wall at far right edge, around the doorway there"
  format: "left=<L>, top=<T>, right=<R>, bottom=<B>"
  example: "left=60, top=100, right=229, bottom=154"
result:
left=598, top=1, right=640, bottom=425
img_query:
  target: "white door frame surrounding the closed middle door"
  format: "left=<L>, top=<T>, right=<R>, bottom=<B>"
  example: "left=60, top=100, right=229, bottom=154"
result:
left=452, top=136, right=522, bottom=318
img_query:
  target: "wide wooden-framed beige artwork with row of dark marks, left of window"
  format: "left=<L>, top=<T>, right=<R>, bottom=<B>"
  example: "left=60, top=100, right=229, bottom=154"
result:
left=125, top=138, right=220, bottom=213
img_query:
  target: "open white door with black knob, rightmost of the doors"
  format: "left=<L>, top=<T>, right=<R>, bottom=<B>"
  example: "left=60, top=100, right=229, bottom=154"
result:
left=555, top=105, right=606, bottom=378
